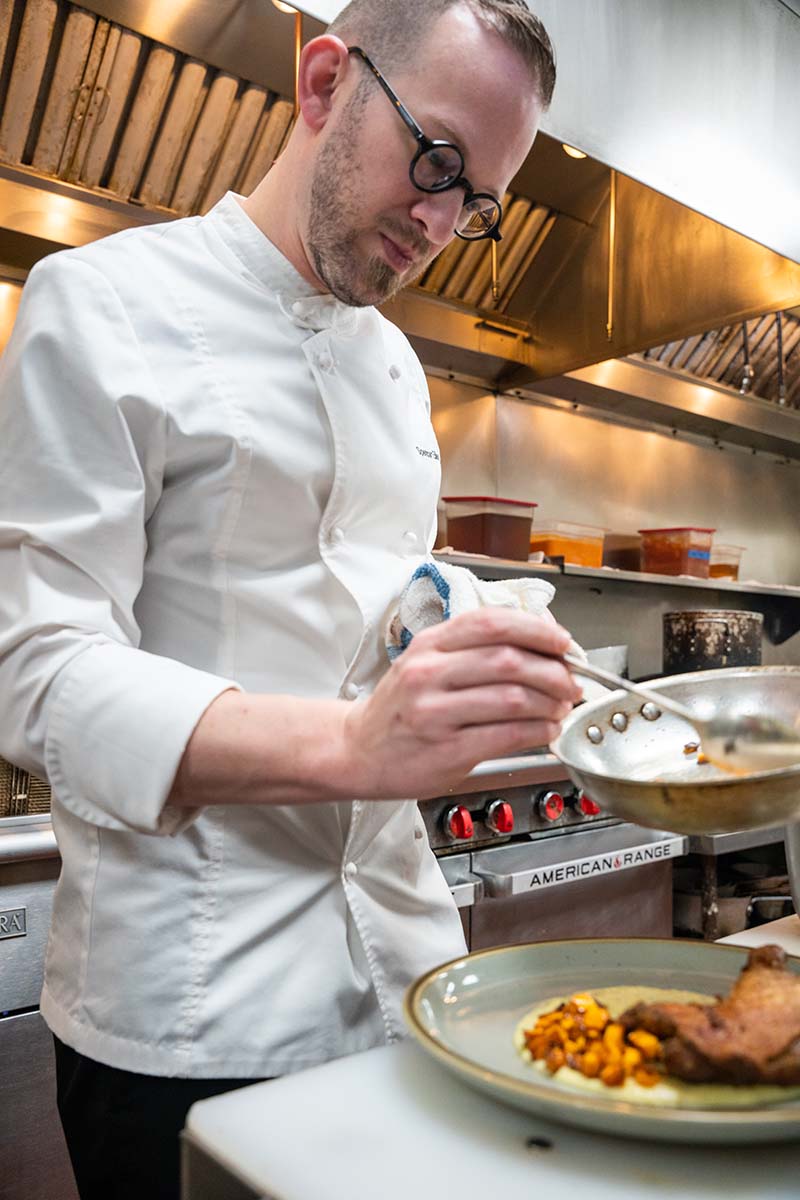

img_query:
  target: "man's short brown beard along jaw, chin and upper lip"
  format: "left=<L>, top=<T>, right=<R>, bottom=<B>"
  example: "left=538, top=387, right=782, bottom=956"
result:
left=308, top=97, right=434, bottom=307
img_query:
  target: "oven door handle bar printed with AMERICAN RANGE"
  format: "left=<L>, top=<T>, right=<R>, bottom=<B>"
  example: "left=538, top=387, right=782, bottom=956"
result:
left=473, top=827, right=686, bottom=900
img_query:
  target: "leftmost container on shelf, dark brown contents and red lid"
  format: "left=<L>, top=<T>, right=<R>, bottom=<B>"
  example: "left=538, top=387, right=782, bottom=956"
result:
left=443, top=496, right=536, bottom=563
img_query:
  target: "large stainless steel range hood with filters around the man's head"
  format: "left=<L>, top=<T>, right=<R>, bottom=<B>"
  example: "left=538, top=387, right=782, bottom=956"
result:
left=0, top=0, right=800, bottom=412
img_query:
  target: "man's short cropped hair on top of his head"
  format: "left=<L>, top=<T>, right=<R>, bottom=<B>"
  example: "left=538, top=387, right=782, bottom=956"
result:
left=329, top=0, right=555, bottom=108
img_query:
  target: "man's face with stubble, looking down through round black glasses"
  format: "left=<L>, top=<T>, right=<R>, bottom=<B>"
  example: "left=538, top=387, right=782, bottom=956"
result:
left=307, top=7, right=541, bottom=305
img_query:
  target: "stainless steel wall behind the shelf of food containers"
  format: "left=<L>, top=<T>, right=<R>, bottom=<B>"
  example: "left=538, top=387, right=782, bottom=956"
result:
left=428, top=377, right=800, bottom=676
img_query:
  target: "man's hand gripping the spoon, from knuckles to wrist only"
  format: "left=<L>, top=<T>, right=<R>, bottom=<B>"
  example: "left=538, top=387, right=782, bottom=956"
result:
left=344, top=607, right=583, bottom=799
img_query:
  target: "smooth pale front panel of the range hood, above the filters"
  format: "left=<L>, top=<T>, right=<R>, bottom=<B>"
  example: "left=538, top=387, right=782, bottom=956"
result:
left=291, top=0, right=800, bottom=262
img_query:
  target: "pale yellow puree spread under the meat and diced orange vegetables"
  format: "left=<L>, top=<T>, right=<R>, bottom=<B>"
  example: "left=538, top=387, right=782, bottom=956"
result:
left=513, top=988, right=800, bottom=1109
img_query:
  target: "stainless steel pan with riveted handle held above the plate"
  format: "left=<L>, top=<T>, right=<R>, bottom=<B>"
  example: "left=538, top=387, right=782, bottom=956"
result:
left=552, top=667, right=800, bottom=834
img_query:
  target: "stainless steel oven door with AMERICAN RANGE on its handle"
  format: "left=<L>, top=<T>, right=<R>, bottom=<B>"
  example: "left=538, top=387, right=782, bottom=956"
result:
left=462, top=823, right=686, bottom=950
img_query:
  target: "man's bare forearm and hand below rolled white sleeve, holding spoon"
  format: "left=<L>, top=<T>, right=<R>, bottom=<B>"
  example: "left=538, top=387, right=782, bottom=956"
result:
left=169, top=607, right=582, bottom=808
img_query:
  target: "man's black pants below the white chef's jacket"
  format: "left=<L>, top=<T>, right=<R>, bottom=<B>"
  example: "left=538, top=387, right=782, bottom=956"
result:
left=53, top=1037, right=272, bottom=1200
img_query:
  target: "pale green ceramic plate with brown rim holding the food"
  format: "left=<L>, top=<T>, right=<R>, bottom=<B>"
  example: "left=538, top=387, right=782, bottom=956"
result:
left=405, top=938, right=800, bottom=1142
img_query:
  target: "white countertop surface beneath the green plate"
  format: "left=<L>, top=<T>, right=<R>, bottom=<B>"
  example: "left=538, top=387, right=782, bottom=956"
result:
left=185, top=916, right=800, bottom=1200
